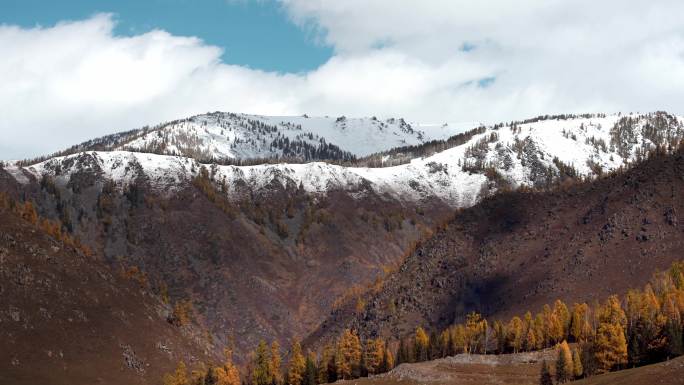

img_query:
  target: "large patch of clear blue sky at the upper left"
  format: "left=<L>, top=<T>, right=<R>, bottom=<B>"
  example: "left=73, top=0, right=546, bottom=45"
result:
left=0, top=0, right=333, bottom=72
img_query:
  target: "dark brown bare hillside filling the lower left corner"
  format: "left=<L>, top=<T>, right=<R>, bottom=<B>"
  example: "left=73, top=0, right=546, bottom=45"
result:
left=0, top=209, right=219, bottom=385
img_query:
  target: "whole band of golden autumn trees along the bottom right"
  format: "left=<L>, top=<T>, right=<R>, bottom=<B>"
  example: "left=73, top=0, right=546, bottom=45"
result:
left=160, top=262, right=684, bottom=385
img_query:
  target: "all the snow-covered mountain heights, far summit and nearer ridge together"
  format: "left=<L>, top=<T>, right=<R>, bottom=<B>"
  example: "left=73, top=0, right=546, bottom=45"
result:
left=6, top=112, right=684, bottom=207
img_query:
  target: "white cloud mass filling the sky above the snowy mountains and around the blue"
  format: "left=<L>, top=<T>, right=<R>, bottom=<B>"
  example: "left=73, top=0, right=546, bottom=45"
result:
left=0, top=0, right=684, bottom=159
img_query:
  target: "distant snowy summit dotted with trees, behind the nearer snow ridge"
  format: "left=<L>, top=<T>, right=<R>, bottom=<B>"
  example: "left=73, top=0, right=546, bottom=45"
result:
left=65, top=112, right=474, bottom=162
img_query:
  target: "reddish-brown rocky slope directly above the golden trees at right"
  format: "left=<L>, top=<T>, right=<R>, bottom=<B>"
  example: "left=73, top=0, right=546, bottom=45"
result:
left=306, top=148, right=684, bottom=346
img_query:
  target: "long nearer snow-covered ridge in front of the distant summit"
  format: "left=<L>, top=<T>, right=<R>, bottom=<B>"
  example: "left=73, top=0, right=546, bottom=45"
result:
left=10, top=113, right=684, bottom=206
